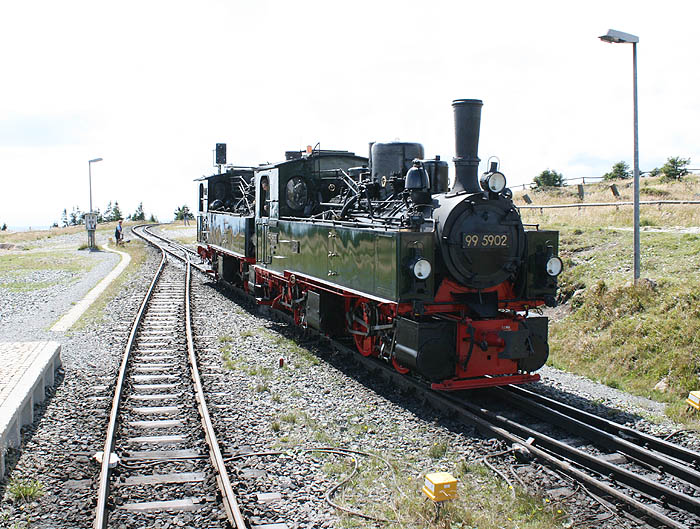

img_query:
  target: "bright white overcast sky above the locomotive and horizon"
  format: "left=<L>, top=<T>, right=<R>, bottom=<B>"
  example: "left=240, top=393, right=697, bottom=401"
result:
left=0, top=0, right=700, bottom=226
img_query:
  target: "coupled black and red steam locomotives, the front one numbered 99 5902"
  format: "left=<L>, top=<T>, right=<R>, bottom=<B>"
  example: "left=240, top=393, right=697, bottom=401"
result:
left=197, top=99, right=562, bottom=390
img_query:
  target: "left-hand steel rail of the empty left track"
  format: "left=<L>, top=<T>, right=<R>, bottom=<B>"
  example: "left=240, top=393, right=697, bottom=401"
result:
left=93, top=249, right=166, bottom=529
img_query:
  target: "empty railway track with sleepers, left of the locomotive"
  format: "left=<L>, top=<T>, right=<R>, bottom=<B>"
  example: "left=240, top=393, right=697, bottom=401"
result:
left=94, top=227, right=246, bottom=529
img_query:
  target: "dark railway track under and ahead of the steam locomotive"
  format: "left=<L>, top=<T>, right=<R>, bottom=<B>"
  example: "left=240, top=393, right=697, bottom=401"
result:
left=138, top=228, right=700, bottom=529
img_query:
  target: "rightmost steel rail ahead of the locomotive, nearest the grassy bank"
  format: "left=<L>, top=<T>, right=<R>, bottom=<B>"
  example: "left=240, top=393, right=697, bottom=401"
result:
left=507, top=386, right=700, bottom=469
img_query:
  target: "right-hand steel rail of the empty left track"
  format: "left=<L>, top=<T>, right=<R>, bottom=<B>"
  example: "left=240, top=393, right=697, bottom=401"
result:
left=185, top=259, right=246, bottom=529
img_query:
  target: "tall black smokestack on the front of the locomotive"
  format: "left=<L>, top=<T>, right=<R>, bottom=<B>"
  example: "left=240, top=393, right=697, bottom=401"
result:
left=451, top=99, right=483, bottom=193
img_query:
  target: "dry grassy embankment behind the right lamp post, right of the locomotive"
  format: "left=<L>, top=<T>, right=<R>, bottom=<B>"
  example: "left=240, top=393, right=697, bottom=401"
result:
left=516, top=176, right=700, bottom=427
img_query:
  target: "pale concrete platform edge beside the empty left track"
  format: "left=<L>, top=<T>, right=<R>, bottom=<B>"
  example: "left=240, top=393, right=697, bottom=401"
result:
left=0, top=342, right=61, bottom=478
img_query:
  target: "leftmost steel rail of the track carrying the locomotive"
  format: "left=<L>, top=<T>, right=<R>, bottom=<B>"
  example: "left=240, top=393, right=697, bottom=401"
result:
left=340, top=346, right=688, bottom=529
